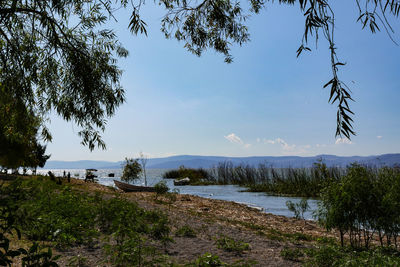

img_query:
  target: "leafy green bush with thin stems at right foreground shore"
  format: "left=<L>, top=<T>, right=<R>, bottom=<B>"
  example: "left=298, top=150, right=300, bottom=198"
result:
left=317, top=164, right=400, bottom=248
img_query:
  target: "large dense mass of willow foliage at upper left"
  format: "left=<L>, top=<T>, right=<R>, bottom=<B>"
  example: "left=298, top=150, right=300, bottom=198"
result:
left=0, top=0, right=127, bottom=150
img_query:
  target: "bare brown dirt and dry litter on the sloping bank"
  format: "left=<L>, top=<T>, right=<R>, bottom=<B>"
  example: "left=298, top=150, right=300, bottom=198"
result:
left=10, top=179, right=333, bottom=266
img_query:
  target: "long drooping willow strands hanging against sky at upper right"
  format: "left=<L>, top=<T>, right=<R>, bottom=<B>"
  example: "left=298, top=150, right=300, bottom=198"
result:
left=280, top=0, right=400, bottom=139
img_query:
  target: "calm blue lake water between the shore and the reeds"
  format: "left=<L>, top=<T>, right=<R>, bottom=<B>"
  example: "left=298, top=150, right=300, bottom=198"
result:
left=38, top=169, right=317, bottom=219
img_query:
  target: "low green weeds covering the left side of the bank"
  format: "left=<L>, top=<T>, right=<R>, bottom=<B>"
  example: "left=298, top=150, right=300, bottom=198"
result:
left=0, top=177, right=171, bottom=266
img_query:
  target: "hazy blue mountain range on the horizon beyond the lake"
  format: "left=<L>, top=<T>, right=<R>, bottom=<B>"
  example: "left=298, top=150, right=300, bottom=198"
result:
left=44, top=153, right=400, bottom=169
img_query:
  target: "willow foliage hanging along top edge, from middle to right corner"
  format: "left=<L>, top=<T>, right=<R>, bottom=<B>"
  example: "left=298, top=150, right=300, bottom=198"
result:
left=161, top=0, right=400, bottom=138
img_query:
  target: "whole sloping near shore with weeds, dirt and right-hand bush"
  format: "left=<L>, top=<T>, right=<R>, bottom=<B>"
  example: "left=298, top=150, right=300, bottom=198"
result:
left=0, top=165, right=400, bottom=266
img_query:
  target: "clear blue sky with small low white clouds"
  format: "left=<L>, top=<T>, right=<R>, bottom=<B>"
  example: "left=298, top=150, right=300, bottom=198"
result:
left=47, top=0, right=400, bottom=161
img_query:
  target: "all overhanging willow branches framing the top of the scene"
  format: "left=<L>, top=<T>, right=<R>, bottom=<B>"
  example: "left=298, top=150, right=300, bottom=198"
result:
left=0, top=0, right=400, bottom=150
